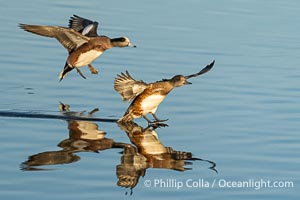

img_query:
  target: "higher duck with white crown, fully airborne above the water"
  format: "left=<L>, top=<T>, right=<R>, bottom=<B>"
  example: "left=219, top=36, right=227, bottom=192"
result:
left=19, top=15, right=136, bottom=81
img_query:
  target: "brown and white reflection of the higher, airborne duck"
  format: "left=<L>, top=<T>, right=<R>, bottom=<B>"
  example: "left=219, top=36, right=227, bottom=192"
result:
left=21, top=103, right=123, bottom=170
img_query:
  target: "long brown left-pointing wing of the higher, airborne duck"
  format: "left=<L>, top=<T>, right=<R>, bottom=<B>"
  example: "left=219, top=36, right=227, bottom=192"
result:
left=19, top=24, right=90, bottom=52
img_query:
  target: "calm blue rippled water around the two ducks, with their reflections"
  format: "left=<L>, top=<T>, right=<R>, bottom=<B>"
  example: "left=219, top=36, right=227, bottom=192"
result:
left=0, top=0, right=300, bottom=199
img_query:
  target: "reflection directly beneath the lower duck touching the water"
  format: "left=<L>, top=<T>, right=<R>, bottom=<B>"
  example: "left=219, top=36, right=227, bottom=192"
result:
left=117, top=121, right=216, bottom=193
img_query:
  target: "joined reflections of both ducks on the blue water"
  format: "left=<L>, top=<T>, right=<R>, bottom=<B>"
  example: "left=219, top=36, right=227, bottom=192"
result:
left=21, top=103, right=217, bottom=194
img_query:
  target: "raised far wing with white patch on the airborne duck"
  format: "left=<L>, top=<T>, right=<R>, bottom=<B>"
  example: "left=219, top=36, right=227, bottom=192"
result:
left=69, top=15, right=98, bottom=37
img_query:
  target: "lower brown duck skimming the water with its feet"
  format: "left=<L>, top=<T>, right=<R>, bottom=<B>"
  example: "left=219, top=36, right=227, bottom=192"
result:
left=114, top=61, right=215, bottom=124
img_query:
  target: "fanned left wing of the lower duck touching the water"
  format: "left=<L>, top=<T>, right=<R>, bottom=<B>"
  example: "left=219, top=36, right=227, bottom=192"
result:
left=114, top=71, right=147, bottom=101
